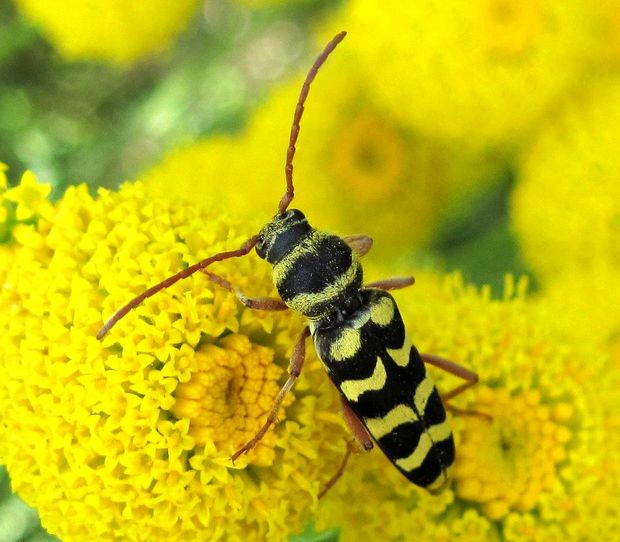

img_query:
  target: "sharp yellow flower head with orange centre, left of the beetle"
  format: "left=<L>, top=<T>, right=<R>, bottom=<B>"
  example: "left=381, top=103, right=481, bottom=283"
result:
left=0, top=176, right=346, bottom=542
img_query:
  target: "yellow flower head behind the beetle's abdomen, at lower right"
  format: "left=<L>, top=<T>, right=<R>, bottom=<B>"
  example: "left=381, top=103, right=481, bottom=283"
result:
left=318, top=276, right=620, bottom=542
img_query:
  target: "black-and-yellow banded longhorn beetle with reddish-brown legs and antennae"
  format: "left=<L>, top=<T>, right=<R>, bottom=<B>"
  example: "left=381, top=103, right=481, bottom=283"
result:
left=97, top=32, right=478, bottom=494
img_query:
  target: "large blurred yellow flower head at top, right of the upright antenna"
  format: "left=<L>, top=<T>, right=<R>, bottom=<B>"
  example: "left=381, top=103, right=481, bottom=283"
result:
left=338, top=0, right=594, bottom=144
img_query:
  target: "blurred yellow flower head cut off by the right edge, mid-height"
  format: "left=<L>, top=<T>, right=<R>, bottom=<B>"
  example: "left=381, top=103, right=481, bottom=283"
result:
left=512, top=78, right=620, bottom=282
